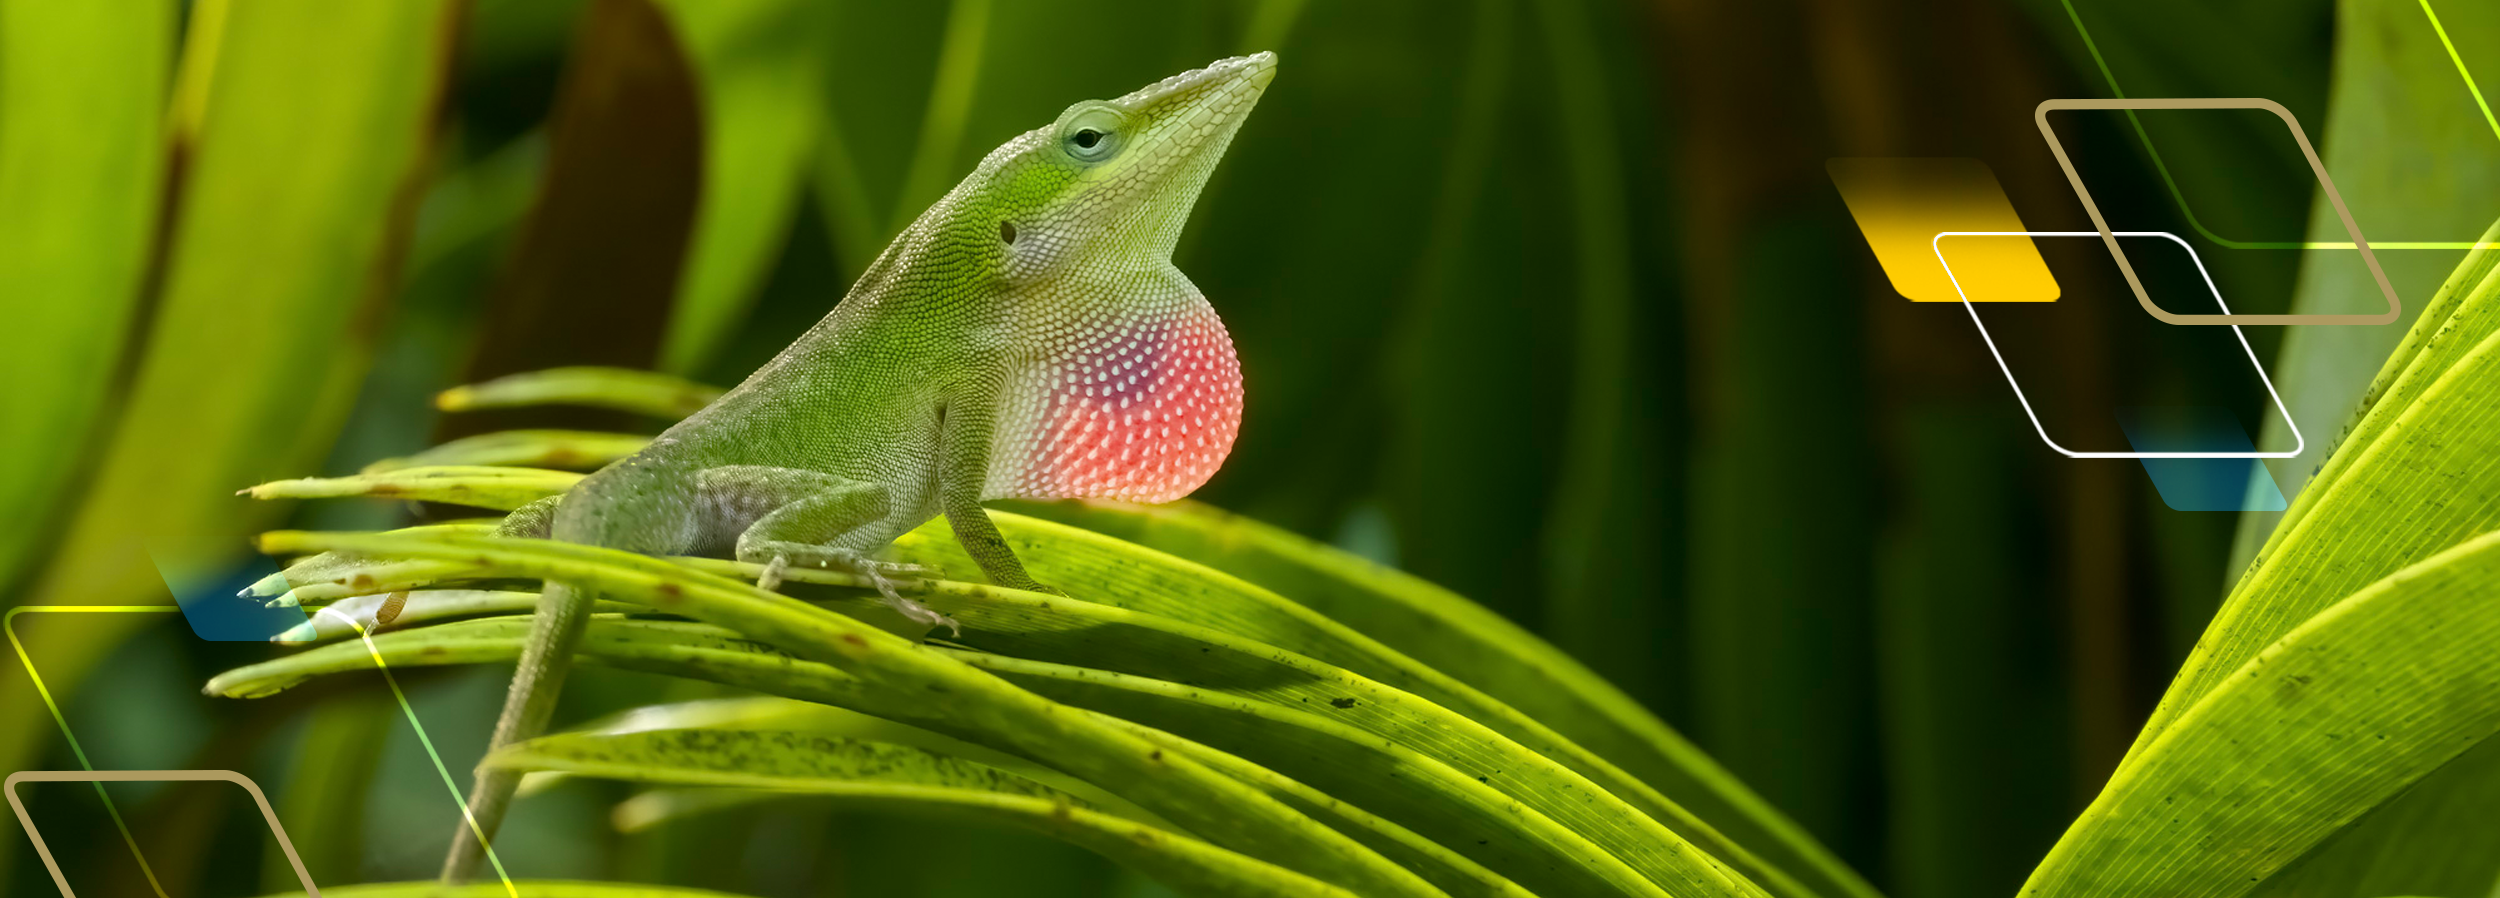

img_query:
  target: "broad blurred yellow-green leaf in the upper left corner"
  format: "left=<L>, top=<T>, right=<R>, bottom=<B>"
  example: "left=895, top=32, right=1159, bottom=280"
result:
left=0, top=0, right=178, bottom=583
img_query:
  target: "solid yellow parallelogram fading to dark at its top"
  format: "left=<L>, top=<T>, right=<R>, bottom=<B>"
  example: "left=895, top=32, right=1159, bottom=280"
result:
left=1823, top=158, right=2058, bottom=303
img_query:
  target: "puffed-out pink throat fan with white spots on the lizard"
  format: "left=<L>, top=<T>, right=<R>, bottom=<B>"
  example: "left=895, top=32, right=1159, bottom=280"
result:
left=983, top=295, right=1243, bottom=503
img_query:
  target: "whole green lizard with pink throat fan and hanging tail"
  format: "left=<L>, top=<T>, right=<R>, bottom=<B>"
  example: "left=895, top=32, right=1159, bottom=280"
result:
left=443, top=53, right=1275, bottom=883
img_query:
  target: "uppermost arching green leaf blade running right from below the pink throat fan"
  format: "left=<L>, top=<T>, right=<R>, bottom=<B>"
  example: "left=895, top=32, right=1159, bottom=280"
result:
left=995, top=503, right=1868, bottom=895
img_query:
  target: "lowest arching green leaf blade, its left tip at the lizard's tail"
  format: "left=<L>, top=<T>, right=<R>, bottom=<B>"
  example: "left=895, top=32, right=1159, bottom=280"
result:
left=485, top=730, right=1353, bottom=898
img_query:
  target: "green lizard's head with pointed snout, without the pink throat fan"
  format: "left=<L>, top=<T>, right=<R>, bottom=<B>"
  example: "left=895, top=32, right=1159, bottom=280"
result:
left=958, top=53, right=1275, bottom=280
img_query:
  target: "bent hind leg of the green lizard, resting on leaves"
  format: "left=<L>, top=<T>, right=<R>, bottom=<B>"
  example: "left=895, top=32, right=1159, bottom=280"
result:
left=698, top=465, right=963, bottom=633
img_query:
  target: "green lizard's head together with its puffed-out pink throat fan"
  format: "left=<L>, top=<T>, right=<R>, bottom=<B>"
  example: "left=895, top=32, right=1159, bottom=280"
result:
left=955, top=53, right=1275, bottom=503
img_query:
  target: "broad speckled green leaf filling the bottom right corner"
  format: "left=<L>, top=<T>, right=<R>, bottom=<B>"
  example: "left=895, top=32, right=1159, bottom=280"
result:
left=2023, top=533, right=2500, bottom=898
